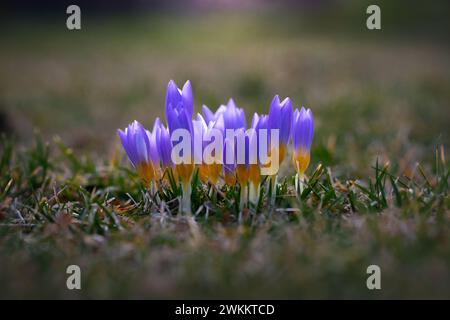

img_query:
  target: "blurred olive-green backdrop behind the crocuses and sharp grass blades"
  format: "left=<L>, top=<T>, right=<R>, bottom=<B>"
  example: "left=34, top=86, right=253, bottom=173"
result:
left=0, top=0, right=450, bottom=177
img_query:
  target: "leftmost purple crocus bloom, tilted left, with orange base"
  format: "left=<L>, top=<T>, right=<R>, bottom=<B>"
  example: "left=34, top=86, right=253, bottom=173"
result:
left=118, top=121, right=159, bottom=184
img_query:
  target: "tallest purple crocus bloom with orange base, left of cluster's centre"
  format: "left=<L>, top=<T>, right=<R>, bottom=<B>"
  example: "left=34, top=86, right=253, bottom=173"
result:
left=166, top=80, right=194, bottom=184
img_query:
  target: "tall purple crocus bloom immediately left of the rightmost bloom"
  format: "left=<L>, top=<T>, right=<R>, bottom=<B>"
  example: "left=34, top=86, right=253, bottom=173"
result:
left=269, top=95, right=292, bottom=164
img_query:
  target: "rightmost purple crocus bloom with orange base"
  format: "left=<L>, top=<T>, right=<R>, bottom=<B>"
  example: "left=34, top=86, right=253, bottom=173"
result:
left=292, top=107, right=314, bottom=176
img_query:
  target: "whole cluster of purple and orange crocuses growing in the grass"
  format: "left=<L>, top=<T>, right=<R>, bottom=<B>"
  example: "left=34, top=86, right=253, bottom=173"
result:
left=118, top=80, right=314, bottom=212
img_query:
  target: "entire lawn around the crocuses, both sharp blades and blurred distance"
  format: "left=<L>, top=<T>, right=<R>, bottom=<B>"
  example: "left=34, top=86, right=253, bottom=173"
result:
left=0, top=7, right=450, bottom=299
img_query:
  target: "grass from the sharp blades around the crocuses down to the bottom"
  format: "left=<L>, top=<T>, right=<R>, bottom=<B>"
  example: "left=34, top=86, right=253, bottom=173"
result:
left=0, top=134, right=450, bottom=298
